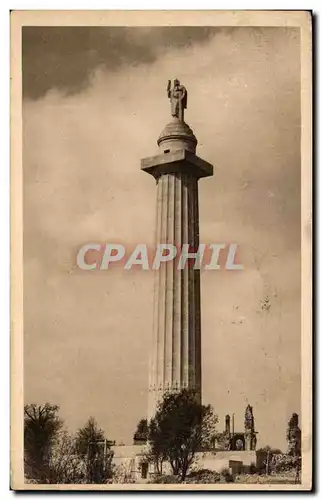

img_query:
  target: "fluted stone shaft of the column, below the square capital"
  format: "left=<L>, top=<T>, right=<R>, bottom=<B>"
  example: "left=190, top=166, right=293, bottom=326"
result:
left=148, top=173, right=201, bottom=418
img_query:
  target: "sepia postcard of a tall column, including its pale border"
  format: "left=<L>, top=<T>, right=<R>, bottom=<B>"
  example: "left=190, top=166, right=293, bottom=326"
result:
left=11, top=11, right=313, bottom=491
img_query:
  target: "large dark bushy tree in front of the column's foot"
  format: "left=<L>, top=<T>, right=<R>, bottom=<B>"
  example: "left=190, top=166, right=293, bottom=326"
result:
left=148, top=389, right=218, bottom=481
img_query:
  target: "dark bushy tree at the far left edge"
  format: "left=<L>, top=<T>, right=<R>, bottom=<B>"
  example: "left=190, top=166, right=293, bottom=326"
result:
left=24, top=403, right=63, bottom=483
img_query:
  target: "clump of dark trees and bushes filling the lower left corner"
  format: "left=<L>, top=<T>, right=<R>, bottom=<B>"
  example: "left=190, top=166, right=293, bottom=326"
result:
left=24, top=403, right=113, bottom=484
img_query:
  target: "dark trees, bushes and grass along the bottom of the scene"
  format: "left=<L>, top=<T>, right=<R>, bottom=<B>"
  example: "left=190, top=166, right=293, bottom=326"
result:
left=24, top=402, right=301, bottom=484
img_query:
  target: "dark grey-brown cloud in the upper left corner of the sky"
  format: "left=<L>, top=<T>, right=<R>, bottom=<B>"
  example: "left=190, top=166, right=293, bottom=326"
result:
left=22, top=26, right=219, bottom=99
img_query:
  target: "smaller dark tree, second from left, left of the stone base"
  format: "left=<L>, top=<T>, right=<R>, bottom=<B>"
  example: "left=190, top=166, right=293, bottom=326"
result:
left=75, top=417, right=113, bottom=484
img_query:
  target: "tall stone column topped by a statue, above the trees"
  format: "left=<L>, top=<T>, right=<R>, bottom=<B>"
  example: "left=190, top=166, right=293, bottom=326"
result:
left=141, top=80, right=213, bottom=419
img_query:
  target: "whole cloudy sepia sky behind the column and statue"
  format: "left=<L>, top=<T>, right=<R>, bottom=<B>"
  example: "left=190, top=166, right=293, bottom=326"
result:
left=22, top=27, right=301, bottom=449
